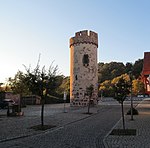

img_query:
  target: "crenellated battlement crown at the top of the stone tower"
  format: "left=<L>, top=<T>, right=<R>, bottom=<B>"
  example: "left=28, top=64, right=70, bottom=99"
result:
left=70, top=30, right=98, bottom=47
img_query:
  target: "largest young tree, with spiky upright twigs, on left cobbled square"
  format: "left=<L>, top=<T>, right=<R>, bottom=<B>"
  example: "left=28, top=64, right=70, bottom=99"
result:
left=26, top=61, right=58, bottom=126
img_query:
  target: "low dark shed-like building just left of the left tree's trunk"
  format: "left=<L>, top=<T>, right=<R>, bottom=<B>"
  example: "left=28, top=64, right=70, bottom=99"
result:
left=22, top=95, right=41, bottom=105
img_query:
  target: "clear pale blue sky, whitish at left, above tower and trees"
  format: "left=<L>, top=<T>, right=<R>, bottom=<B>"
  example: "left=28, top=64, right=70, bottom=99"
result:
left=0, top=0, right=150, bottom=82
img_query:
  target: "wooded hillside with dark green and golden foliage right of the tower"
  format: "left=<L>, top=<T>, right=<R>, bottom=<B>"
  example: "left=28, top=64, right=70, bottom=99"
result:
left=98, top=59, right=144, bottom=97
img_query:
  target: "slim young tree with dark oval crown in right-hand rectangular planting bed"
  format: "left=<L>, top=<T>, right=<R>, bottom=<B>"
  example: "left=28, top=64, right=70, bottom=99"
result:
left=113, top=77, right=130, bottom=130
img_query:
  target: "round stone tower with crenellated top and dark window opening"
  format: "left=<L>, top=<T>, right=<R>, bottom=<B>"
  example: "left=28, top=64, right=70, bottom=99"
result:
left=70, top=30, right=98, bottom=106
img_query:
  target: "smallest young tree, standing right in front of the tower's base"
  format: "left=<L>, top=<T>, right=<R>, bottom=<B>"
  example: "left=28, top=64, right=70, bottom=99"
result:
left=86, top=84, right=94, bottom=114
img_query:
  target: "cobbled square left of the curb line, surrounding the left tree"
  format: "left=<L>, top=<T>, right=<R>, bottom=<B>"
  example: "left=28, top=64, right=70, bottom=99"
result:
left=0, top=104, right=91, bottom=142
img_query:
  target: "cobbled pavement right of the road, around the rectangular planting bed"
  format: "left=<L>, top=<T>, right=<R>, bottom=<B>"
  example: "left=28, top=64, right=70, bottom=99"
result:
left=104, top=99, right=150, bottom=148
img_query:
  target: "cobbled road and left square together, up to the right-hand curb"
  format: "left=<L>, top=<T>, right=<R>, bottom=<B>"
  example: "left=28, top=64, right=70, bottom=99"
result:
left=0, top=104, right=128, bottom=148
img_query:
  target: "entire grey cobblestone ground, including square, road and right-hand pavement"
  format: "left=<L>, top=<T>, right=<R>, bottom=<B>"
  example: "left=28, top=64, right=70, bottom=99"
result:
left=0, top=100, right=150, bottom=148
